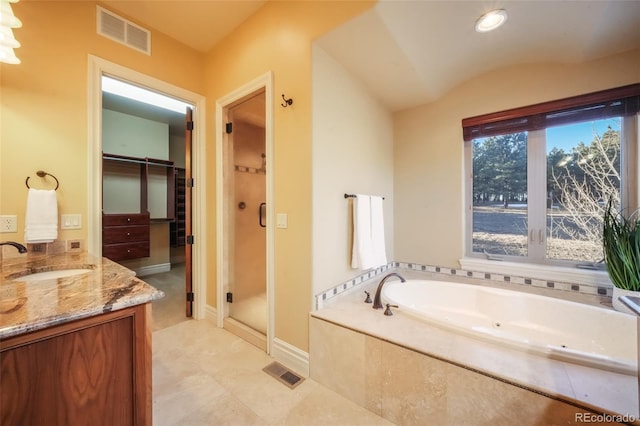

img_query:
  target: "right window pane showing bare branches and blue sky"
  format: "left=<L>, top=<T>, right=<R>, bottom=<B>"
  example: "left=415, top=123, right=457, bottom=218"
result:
left=547, top=118, right=621, bottom=262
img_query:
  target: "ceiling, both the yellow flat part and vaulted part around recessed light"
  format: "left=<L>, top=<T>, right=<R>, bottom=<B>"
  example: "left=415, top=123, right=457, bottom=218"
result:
left=102, top=0, right=640, bottom=111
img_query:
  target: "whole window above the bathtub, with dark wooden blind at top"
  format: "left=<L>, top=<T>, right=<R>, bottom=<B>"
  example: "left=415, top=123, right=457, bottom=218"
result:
left=462, top=84, right=640, bottom=267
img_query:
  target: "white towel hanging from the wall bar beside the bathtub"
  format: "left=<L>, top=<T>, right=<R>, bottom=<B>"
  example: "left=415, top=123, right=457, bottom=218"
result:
left=351, top=194, right=387, bottom=269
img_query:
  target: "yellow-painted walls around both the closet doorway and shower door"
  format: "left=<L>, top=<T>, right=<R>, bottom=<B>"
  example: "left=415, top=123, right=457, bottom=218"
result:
left=0, top=1, right=375, bottom=356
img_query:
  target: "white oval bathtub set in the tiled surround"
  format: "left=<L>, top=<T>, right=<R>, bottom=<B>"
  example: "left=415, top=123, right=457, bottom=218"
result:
left=382, top=280, right=638, bottom=375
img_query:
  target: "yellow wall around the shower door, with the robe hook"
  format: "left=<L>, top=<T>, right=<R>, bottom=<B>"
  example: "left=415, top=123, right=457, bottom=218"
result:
left=206, top=1, right=374, bottom=351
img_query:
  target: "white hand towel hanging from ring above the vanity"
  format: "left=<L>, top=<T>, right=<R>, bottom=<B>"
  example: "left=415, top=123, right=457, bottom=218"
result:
left=24, top=188, right=58, bottom=243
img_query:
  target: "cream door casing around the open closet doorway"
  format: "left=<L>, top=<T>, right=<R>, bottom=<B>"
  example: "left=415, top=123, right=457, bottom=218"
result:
left=86, top=55, right=207, bottom=319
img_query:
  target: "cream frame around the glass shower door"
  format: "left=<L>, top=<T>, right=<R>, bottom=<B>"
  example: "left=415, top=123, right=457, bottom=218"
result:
left=215, top=71, right=275, bottom=354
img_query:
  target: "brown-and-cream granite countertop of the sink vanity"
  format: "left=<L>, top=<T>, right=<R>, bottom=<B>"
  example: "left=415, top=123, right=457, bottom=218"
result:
left=0, top=252, right=164, bottom=339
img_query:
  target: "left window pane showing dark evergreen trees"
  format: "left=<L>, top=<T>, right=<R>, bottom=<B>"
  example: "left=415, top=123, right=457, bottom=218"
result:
left=472, top=132, right=528, bottom=256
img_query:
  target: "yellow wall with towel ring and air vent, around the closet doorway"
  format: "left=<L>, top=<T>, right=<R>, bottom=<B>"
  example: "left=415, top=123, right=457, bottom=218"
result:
left=0, top=1, right=204, bottom=246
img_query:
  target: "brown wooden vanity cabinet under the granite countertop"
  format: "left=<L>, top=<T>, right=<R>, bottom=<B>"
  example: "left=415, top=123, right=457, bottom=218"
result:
left=0, top=303, right=152, bottom=426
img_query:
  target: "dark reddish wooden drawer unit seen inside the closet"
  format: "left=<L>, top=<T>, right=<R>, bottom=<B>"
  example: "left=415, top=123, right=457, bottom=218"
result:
left=102, top=212, right=151, bottom=262
